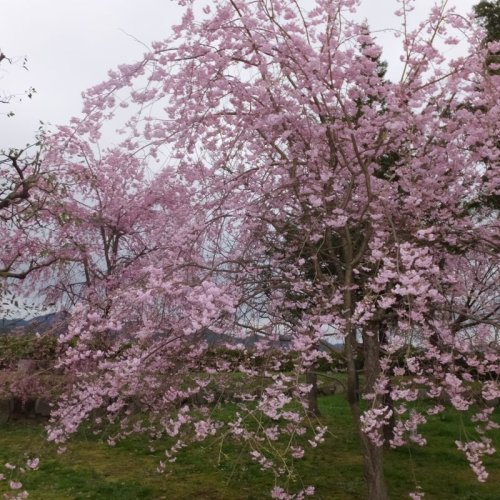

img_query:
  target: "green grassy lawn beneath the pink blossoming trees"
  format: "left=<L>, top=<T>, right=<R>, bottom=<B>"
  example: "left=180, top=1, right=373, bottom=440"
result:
left=0, top=396, right=500, bottom=500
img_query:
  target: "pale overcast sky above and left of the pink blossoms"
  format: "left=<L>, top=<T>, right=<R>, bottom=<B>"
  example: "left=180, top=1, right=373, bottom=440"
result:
left=0, top=0, right=477, bottom=148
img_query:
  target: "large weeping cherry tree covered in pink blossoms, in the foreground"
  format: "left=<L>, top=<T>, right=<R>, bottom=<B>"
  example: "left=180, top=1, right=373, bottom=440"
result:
left=8, top=0, right=500, bottom=499
